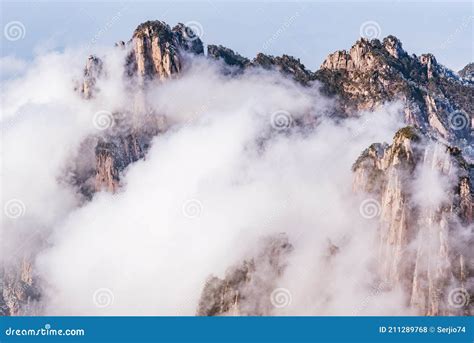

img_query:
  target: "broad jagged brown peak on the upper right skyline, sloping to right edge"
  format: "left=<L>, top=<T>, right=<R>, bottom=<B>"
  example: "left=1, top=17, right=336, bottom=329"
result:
left=315, top=36, right=474, bottom=146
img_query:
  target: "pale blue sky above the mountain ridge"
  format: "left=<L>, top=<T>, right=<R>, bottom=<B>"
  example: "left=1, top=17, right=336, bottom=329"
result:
left=1, top=0, right=474, bottom=70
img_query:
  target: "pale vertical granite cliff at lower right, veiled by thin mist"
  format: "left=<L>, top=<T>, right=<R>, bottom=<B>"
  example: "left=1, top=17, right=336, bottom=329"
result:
left=353, top=127, right=474, bottom=315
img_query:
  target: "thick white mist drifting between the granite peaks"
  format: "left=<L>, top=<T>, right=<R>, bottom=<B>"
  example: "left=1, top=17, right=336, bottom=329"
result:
left=0, top=49, right=422, bottom=315
